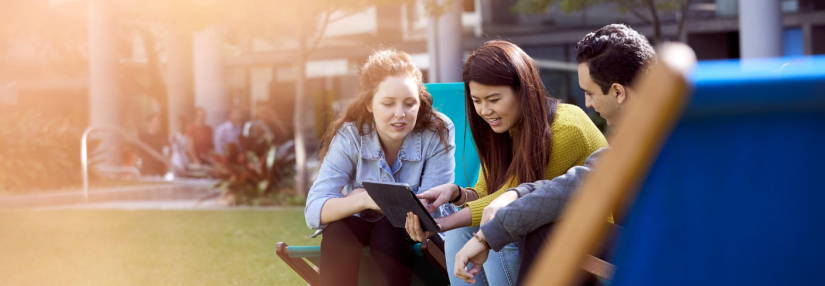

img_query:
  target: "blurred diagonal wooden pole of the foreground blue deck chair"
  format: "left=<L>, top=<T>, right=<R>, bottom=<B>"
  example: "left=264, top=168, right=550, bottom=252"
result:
left=523, top=44, right=696, bottom=286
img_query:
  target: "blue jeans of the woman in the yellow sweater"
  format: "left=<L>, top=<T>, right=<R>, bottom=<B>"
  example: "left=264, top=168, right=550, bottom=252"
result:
left=444, top=226, right=520, bottom=286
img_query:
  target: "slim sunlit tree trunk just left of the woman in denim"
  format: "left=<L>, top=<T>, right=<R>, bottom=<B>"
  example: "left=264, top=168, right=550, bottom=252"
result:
left=293, top=25, right=309, bottom=197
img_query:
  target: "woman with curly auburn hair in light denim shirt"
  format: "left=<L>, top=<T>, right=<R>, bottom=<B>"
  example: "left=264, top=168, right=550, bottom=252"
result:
left=304, top=50, right=455, bottom=285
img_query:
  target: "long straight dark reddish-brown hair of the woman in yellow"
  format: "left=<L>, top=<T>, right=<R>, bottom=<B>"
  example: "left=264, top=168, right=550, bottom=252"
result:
left=463, top=40, right=558, bottom=194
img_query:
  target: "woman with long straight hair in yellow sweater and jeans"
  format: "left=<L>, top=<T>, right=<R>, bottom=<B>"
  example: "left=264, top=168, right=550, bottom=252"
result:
left=407, top=41, right=607, bottom=286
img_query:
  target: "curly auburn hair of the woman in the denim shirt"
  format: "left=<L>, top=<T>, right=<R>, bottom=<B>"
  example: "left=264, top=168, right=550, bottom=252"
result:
left=319, top=49, right=450, bottom=162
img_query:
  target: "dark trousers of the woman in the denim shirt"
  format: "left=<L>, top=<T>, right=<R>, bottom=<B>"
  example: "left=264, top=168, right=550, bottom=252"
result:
left=321, top=217, right=414, bottom=285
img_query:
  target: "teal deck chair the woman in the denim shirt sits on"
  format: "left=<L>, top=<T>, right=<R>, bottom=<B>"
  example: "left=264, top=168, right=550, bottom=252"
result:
left=276, top=83, right=480, bottom=285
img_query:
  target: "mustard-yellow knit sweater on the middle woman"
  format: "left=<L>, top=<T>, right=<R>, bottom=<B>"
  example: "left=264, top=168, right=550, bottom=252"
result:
left=467, top=104, right=607, bottom=226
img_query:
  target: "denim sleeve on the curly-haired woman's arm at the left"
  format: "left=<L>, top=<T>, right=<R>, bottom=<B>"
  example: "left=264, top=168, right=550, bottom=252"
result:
left=304, top=131, right=356, bottom=229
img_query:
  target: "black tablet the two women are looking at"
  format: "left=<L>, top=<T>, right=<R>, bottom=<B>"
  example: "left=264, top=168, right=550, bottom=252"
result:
left=363, top=182, right=440, bottom=233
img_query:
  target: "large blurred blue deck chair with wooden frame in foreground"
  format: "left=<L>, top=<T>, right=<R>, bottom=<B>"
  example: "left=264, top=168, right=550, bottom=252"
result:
left=528, top=45, right=825, bottom=286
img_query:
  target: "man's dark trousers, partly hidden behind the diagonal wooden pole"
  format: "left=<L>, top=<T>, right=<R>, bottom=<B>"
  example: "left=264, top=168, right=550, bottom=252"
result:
left=516, top=223, right=620, bottom=285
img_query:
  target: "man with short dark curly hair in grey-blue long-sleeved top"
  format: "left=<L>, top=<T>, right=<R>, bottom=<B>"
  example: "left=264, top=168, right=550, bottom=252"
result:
left=454, top=24, right=656, bottom=284
